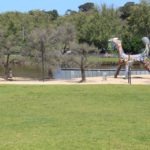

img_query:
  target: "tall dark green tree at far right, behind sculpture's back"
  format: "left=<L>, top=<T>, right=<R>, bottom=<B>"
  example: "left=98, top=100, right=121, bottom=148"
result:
left=121, top=0, right=150, bottom=54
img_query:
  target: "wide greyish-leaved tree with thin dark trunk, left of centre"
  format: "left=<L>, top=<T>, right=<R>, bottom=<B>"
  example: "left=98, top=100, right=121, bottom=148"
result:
left=26, top=24, right=75, bottom=80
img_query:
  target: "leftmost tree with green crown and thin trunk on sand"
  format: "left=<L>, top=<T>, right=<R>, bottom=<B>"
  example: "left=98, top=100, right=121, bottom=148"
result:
left=0, top=13, right=22, bottom=80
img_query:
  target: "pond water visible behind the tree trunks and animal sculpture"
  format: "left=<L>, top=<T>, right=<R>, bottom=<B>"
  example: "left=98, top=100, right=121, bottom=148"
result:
left=0, top=65, right=149, bottom=80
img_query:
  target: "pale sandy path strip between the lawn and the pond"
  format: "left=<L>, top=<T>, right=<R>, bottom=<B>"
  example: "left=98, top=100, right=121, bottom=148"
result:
left=0, top=75, right=150, bottom=85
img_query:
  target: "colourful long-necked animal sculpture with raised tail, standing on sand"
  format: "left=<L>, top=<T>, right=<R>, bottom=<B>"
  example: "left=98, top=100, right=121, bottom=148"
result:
left=109, top=37, right=150, bottom=78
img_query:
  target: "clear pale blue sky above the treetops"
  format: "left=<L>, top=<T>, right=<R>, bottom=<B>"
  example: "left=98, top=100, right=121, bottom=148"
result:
left=0, top=0, right=140, bottom=15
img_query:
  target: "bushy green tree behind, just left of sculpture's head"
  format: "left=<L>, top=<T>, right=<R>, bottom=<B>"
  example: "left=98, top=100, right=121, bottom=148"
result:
left=77, top=5, right=122, bottom=50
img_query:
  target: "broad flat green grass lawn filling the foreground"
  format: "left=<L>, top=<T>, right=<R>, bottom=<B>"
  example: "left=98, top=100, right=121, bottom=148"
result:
left=0, top=85, right=150, bottom=150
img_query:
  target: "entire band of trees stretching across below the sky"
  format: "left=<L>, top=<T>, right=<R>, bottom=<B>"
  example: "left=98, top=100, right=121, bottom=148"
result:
left=0, top=0, right=150, bottom=81
